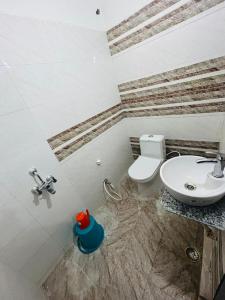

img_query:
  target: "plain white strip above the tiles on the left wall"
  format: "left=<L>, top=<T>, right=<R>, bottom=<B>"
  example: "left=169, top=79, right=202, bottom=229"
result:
left=0, top=0, right=105, bottom=30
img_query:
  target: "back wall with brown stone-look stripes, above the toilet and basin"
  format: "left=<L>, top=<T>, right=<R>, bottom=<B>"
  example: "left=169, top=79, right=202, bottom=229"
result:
left=104, top=0, right=225, bottom=147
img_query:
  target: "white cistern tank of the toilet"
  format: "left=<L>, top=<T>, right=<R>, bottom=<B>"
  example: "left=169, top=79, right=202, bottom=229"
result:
left=140, top=134, right=166, bottom=159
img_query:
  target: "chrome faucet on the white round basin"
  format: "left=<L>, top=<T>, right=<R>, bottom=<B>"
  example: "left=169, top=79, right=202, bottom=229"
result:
left=196, top=152, right=225, bottom=178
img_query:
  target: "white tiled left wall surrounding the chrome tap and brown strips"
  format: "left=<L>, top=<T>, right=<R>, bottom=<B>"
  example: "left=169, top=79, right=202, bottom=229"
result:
left=0, top=2, right=131, bottom=283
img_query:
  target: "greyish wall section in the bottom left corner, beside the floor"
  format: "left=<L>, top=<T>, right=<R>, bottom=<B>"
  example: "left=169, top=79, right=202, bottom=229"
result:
left=0, top=263, right=45, bottom=300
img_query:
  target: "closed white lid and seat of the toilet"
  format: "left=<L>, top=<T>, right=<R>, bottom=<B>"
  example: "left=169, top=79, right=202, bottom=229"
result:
left=128, top=155, right=162, bottom=183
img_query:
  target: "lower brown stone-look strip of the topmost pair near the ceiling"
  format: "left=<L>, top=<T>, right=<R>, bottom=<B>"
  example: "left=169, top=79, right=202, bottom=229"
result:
left=109, top=0, right=224, bottom=55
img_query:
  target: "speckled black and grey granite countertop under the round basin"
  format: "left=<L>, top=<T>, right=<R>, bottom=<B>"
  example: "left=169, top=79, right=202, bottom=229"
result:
left=161, top=190, right=225, bottom=230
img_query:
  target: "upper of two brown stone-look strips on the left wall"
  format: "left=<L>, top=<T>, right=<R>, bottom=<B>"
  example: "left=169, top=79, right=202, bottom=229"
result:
left=48, top=104, right=121, bottom=149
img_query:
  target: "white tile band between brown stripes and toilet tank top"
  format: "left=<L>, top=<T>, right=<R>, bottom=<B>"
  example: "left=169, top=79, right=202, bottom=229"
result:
left=125, top=113, right=225, bottom=142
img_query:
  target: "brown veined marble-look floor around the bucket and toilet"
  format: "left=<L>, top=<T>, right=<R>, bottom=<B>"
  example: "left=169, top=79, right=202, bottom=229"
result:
left=43, top=177, right=203, bottom=300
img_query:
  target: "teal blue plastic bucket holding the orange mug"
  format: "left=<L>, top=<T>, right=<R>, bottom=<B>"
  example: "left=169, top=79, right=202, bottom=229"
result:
left=73, top=216, right=104, bottom=254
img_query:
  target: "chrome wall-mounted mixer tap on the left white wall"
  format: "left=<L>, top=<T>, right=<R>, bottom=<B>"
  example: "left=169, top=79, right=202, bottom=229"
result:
left=29, top=168, right=57, bottom=195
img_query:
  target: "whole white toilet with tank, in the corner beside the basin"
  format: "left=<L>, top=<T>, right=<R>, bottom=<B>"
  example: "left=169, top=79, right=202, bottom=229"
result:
left=128, top=134, right=166, bottom=196
